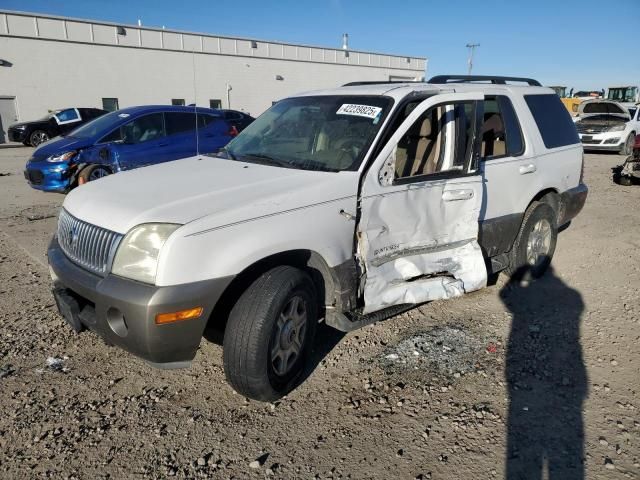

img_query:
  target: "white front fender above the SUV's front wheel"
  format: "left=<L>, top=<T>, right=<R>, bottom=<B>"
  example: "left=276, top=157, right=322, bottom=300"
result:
left=156, top=196, right=356, bottom=286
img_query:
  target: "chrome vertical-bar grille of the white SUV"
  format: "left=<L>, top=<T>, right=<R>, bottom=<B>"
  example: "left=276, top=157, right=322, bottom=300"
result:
left=58, top=208, right=123, bottom=276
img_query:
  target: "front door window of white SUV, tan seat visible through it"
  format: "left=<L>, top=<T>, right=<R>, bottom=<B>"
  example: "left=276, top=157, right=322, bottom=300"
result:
left=394, top=103, right=473, bottom=180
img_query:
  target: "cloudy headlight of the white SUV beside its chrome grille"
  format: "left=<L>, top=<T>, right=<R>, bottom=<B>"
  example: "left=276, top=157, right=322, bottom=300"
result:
left=111, top=223, right=181, bottom=284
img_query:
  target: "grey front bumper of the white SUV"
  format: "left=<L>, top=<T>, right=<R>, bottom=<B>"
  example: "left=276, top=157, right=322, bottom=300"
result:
left=48, top=237, right=233, bottom=368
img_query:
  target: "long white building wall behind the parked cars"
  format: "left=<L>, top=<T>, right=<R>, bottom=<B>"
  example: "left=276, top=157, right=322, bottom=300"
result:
left=0, top=11, right=426, bottom=120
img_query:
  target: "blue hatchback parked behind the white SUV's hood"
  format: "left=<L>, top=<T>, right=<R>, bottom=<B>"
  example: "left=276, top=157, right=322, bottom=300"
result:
left=24, top=105, right=238, bottom=193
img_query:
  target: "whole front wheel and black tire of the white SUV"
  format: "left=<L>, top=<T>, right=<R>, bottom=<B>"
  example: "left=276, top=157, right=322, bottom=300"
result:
left=223, top=266, right=318, bottom=401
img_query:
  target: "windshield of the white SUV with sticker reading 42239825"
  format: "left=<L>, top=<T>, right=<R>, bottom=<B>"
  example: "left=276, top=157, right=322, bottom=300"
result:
left=221, top=95, right=392, bottom=171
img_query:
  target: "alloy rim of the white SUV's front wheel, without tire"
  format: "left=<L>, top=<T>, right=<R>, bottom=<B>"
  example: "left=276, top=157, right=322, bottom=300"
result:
left=271, top=296, right=307, bottom=376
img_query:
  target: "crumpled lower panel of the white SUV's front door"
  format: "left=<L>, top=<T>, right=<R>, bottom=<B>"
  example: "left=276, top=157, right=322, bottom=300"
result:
left=358, top=176, right=487, bottom=314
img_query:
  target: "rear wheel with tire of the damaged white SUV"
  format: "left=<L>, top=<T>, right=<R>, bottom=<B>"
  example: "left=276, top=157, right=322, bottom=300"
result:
left=507, top=202, right=558, bottom=280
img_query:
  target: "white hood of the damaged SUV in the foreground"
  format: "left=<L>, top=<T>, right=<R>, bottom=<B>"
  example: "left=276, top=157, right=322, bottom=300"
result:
left=63, top=156, right=358, bottom=234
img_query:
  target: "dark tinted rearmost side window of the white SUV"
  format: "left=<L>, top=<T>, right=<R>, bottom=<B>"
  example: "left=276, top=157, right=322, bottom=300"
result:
left=524, top=94, right=580, bottom=148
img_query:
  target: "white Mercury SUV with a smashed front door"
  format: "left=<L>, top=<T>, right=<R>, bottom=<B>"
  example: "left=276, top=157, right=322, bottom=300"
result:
left=48, top=77, right=587, bottom=400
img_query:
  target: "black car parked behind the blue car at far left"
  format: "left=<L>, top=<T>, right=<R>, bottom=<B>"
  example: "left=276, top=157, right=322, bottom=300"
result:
left=7, top=108, right=108, bottom=147
